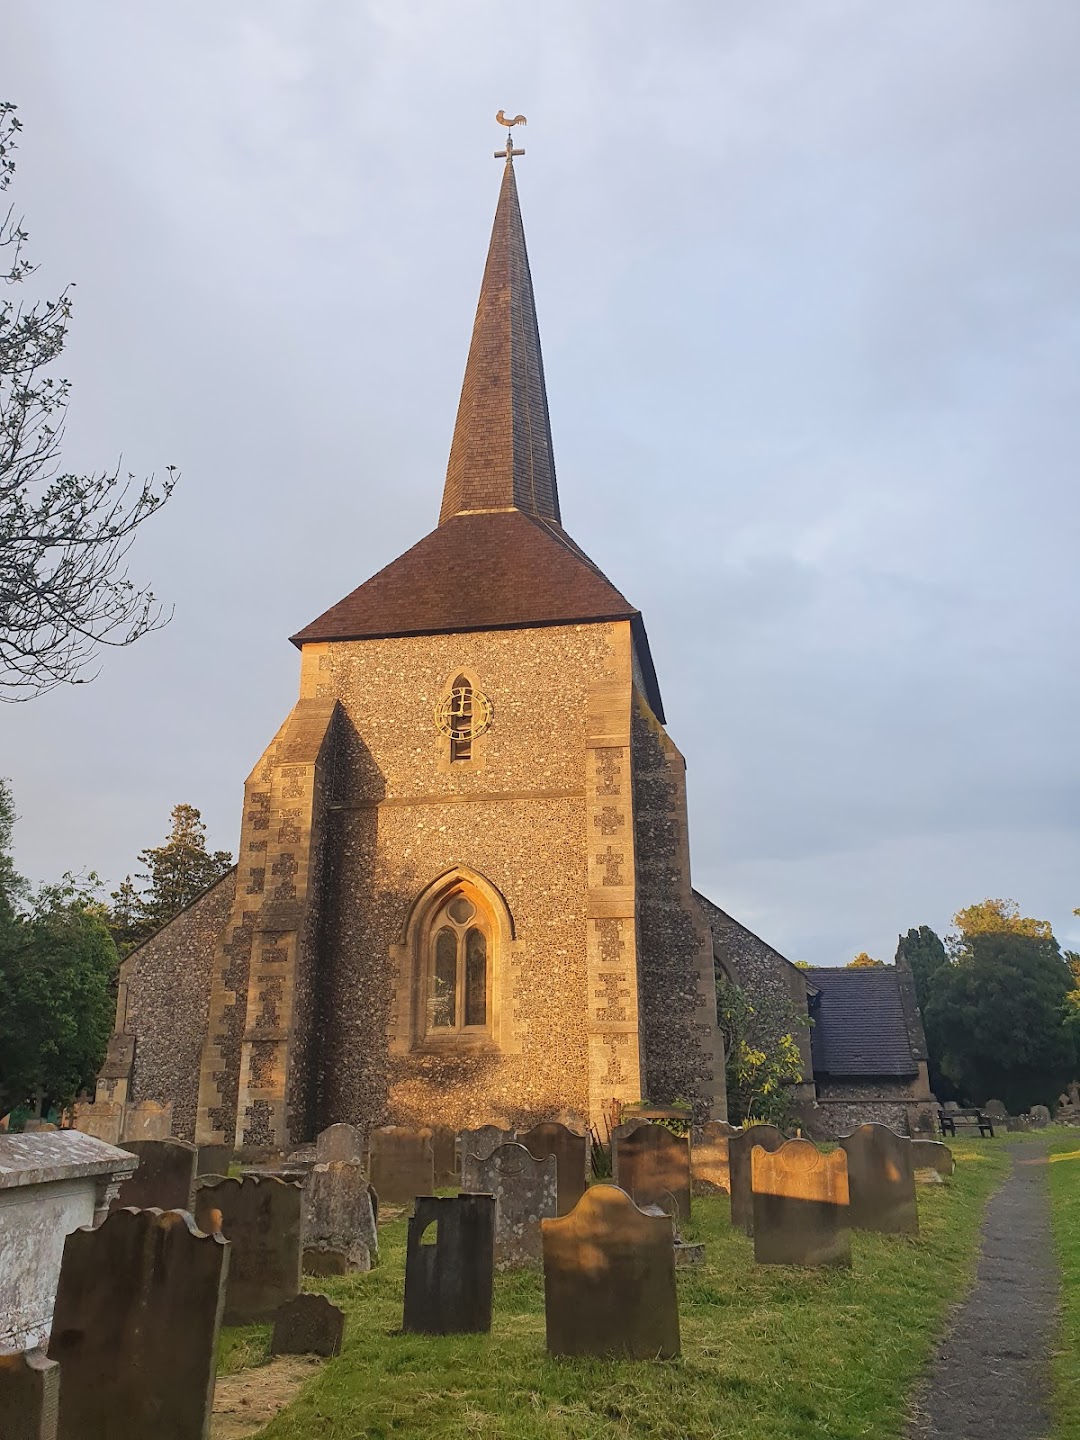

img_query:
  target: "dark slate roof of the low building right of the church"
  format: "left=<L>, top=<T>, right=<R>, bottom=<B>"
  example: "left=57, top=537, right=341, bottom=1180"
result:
left=806, top=965, right=919, bottom=1077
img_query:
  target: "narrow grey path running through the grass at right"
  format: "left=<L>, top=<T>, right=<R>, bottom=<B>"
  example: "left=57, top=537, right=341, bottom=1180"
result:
left=907, top=1143, right=1060, bottom=1440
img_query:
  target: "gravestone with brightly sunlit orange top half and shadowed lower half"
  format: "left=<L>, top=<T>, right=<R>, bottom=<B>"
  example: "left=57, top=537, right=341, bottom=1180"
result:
left=750, top=1140, right=851, bottom=1266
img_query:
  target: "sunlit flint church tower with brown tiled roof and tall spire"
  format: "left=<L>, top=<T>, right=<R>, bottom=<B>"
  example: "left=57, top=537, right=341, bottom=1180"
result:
left=99, top=144, right=726, bottom=1155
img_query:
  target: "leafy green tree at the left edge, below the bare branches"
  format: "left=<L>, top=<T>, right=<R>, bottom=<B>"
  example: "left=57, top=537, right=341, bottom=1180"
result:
left=0, top=876, right=118, bottom=1110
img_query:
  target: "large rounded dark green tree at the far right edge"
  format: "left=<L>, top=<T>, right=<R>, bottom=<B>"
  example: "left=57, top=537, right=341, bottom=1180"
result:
left=926, top=927, right=1080, bottom=1113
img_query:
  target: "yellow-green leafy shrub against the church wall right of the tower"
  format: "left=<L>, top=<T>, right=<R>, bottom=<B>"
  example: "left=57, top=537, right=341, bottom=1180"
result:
left=716, top=978, right=809, bottom=1125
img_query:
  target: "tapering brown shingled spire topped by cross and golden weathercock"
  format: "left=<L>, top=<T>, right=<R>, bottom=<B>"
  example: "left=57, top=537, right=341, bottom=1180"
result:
left=439, top=123, right=560, bottom=524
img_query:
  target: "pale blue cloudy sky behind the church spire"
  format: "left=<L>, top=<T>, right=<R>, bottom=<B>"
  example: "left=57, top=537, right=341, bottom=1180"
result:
left=0, top=0, right=1080, bottom=965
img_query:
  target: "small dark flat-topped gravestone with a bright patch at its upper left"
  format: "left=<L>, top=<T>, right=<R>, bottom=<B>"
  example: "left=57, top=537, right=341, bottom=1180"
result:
left=402, top=1195, right=495, bottom=1335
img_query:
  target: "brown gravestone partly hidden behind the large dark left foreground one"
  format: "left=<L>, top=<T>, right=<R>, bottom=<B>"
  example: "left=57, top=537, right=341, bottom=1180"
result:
left=192, top=1175, right=304, bottom=1325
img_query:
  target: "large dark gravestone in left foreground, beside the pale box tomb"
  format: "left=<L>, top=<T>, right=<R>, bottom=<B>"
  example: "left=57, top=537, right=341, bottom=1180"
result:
left=49, top=1210, right=230, bottom=1440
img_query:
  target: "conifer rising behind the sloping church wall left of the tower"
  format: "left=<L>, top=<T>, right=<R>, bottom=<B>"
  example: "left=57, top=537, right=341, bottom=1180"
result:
left=109, top=805, right=233, bottom=955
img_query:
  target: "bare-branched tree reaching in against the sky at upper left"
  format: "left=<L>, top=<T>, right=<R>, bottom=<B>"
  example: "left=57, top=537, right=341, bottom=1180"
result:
left=0, top=102, right=174, bottom=700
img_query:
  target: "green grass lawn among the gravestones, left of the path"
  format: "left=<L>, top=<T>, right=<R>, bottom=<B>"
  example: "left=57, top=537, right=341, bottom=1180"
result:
left=222, top=1140, right=1013, bottom=1440
